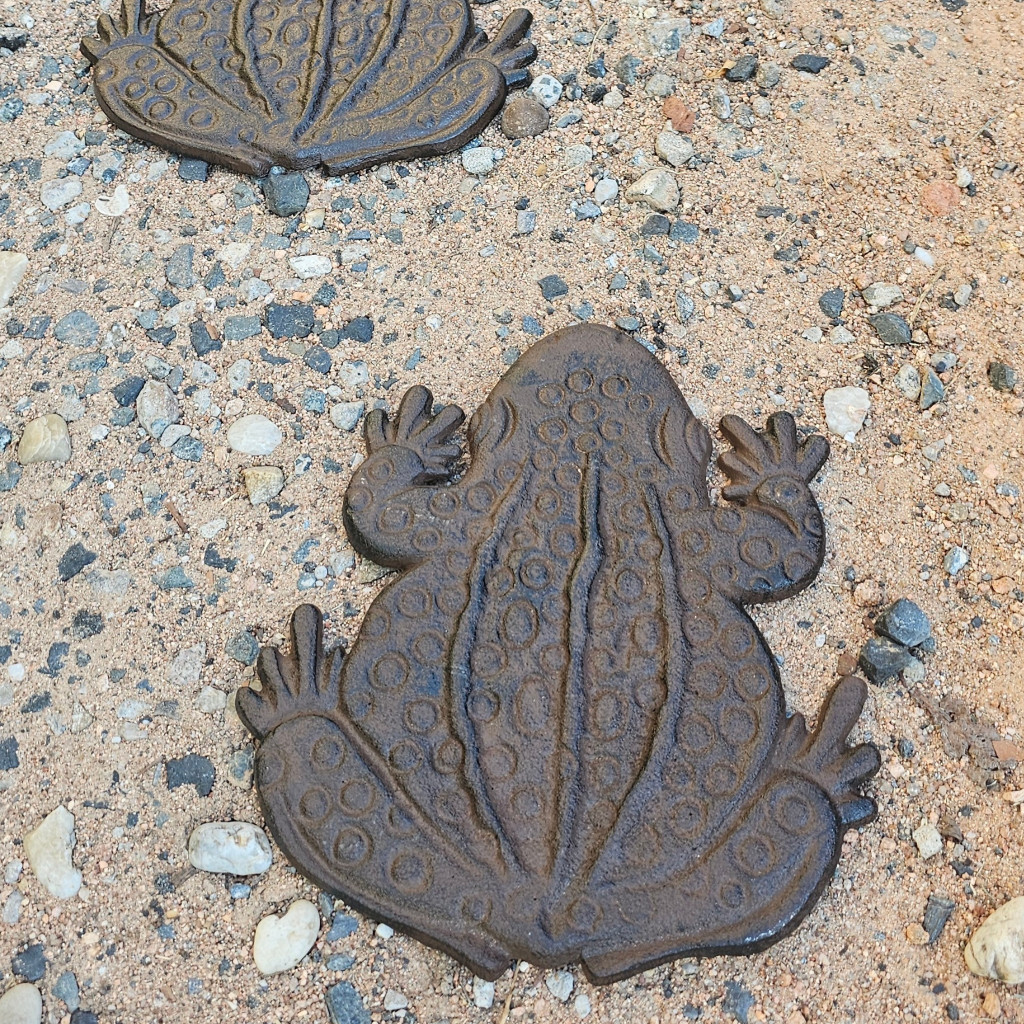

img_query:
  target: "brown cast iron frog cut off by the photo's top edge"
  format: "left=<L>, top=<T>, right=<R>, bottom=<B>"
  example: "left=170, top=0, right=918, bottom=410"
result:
left=82, top=0, right=537, bottom=174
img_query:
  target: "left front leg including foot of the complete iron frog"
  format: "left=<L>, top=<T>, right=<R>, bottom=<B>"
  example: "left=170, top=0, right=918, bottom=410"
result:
left=342, top=385, right=465, bottom=568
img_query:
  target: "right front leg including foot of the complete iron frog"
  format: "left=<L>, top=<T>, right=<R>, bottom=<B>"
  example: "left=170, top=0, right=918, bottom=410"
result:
left=677, top=413, right=828, bottom=604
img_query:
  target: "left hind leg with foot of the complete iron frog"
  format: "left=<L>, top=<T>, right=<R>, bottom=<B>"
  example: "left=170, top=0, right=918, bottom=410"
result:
left=238, top=605, right=512, bottom=978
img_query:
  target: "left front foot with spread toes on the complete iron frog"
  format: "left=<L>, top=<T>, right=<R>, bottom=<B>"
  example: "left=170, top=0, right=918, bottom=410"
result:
left=365, top=384, right=466, bottom=483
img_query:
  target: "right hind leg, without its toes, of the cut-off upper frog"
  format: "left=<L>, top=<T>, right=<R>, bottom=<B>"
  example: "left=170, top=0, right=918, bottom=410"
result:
left=315, top=57, right=507, bottom=174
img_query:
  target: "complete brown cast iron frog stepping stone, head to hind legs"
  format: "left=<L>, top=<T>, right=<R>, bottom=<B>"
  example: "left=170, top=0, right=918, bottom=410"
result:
left=238, top=326, right=879, bottom=982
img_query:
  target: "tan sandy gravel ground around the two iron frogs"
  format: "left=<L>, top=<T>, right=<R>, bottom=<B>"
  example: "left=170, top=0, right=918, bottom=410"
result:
left=0, top=0, right=1024, bottom=1024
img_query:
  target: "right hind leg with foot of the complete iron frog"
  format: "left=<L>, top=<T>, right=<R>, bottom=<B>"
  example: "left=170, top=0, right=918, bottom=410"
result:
left=583, top=679, right=879, bottom=983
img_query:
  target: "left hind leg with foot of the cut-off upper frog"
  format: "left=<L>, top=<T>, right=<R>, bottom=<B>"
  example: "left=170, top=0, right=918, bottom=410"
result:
left=81, top=0, right=270, bottom=175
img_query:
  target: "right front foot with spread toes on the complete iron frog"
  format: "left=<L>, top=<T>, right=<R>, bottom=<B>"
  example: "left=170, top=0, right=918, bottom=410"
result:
left=718, top=413, right=828, bottom=526
